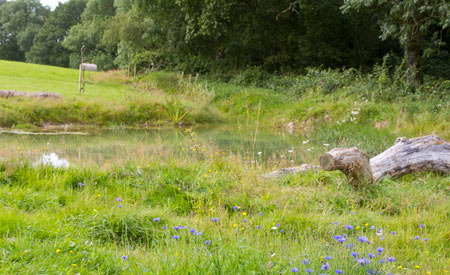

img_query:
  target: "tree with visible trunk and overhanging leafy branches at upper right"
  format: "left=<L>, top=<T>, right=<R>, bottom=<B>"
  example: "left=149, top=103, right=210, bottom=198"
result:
left=342, top=0, right=450, bottom=84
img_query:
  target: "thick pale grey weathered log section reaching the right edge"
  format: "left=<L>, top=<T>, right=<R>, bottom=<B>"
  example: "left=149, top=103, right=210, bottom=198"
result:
left=370, top=135, right=450, bottom=181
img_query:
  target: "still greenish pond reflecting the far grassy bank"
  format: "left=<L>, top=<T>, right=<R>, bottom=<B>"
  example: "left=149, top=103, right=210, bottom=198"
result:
left=0, top=127, right=329, bottom=167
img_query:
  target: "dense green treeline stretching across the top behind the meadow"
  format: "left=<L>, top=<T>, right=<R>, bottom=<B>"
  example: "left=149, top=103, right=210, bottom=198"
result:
left=0, top=0, right=450, bottom=79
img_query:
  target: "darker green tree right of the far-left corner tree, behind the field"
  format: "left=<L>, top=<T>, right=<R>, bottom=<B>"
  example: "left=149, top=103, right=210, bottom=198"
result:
left=26, top=0, right=86, bottom=67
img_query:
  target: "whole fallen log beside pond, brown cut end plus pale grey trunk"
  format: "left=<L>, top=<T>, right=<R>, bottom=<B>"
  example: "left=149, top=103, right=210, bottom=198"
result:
left=320, top=135, right=450, bottom=186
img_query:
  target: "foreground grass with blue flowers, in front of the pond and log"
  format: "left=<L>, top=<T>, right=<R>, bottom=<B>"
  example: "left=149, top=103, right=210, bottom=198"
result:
left=0, top=157, right=450, bottom=274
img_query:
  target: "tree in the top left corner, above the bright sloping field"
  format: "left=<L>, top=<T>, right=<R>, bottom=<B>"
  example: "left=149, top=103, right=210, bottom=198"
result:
left=0, top=0, right=50, bottom=61
